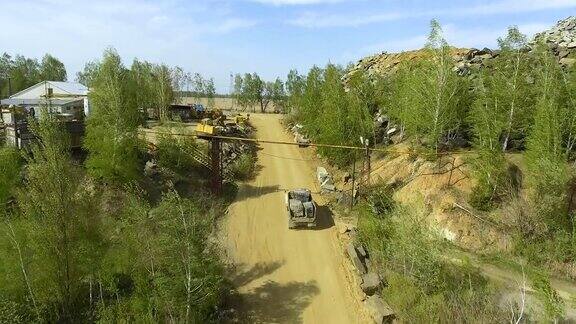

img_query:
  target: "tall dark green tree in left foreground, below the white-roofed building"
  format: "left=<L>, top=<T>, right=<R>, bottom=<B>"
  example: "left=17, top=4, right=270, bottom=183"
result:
left=17, top=108, right=95, bottom=322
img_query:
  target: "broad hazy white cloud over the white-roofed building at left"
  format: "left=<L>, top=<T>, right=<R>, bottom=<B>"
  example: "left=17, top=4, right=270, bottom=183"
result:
left=0, top=0, right=258, bottom=90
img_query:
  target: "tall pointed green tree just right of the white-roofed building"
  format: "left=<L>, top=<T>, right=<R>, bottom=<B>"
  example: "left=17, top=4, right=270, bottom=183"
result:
left=84, top=49, right=139, bottom=183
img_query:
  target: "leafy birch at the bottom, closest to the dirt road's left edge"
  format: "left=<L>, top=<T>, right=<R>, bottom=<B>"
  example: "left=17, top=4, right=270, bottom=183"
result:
left=152, top=192, right=222, bottom=322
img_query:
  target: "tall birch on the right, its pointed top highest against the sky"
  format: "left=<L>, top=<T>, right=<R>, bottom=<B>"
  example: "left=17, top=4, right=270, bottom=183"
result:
left=390, top=20, right=469, bottom=152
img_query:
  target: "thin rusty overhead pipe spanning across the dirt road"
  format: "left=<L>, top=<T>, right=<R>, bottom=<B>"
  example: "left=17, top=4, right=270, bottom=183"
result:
left=144, top=130, right=474, bottom=155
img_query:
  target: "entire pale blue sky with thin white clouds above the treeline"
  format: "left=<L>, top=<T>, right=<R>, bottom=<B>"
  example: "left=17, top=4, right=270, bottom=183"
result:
left=0, top=0, right=576, bottom=92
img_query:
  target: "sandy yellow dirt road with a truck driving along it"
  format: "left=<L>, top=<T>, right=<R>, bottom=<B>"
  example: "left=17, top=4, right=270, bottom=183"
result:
left=221, top=115, right=361, bottom=323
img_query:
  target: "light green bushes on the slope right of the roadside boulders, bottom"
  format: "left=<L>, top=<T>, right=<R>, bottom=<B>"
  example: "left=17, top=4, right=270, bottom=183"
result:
left=359, top=199, right=506, bottom=323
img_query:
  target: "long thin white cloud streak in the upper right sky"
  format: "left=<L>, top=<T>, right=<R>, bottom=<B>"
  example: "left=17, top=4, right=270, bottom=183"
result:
left=290, top=0, right=576, bottom=28
